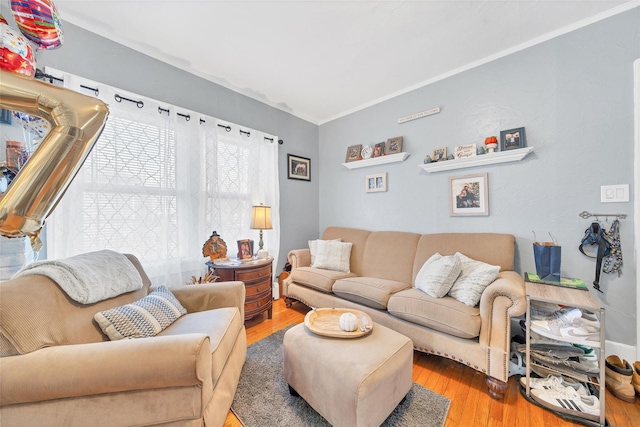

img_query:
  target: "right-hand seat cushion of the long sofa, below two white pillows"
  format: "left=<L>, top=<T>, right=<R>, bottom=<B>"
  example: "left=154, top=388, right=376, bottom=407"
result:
left=387, top=288, right=481, bottom=338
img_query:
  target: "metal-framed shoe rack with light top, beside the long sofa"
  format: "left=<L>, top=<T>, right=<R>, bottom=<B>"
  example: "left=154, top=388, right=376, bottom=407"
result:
left=523, top=282, right=609, bottom=427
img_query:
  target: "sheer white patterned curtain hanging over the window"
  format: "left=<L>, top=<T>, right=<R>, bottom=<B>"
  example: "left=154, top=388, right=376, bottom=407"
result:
left=46, top=68, right=280, bottom=286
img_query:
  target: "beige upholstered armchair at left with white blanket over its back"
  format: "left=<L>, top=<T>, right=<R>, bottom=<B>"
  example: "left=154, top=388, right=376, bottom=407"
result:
left=0, top=255, right=247, bottom=427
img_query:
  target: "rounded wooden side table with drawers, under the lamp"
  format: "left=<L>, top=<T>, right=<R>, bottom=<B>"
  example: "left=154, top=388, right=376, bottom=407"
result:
left=207, top=257, right=273, bottom=321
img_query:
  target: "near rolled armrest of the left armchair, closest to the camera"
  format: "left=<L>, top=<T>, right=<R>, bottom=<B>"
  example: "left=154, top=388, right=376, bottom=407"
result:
left=0, top=334, right=213, bottom=407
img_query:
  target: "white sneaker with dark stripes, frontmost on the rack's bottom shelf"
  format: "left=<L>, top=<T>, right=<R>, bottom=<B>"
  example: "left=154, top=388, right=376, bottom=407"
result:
left=531, top=387, right=600, bottom=421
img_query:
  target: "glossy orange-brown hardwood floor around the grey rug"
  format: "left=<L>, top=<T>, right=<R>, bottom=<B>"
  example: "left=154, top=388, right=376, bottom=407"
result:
left=224, top=298, right=640, bottom=427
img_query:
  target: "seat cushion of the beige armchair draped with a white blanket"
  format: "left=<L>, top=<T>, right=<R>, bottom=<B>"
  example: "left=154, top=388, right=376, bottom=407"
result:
left=158, top=307, right=244, bottom=389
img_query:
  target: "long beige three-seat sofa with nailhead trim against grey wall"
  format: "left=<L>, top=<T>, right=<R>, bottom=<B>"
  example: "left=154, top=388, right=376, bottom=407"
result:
left=283, top=227, right=526, bottom=399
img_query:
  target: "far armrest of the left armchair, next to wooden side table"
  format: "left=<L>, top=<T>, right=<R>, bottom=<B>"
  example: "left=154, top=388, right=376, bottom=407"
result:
left=171, top=281, right=246, bottom=319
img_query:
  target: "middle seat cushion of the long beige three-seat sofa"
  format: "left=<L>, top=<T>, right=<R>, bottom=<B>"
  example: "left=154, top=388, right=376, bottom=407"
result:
left=333, top=277, right=411, bottom=310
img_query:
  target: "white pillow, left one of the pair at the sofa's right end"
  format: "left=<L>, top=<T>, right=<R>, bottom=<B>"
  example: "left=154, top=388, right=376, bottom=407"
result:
left=416, top=253, right=462, bottom=298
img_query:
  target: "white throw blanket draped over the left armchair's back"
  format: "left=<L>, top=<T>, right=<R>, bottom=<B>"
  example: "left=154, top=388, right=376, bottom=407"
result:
left=13, top=250, right=142, bottom=304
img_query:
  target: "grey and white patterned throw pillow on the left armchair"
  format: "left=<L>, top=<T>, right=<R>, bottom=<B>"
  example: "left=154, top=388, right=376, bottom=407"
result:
left=94, top=286, right=187, bottom=341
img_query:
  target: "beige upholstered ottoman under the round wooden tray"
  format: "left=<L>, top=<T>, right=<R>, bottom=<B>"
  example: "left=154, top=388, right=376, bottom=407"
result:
left=283, top=324, right=413, bottom=427
